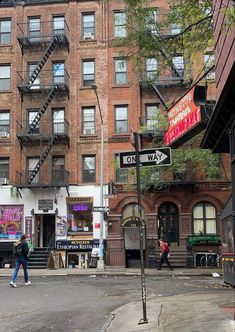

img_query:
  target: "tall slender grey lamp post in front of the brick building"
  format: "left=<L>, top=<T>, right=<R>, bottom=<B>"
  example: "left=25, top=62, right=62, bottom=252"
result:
left=91, top=84, right=104, bottom=270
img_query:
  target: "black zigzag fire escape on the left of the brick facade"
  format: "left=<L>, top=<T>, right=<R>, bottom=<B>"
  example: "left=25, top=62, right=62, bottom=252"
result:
left=17, top=20, right=70, bottom=191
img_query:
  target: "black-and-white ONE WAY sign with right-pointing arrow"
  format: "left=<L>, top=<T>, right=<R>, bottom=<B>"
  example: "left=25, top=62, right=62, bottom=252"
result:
left=119, top=147, right=171, bottom=168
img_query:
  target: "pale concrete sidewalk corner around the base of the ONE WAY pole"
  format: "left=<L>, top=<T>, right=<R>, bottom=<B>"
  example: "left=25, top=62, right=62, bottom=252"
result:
left=105, top=288, right=235, bottom=332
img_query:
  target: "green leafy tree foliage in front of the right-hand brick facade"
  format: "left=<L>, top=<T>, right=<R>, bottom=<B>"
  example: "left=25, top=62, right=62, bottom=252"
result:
left=114, top=0, right=233, bottom=191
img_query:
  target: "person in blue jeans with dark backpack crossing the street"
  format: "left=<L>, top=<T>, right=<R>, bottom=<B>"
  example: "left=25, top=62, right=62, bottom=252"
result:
left=10, top=234, right=31, bottom=288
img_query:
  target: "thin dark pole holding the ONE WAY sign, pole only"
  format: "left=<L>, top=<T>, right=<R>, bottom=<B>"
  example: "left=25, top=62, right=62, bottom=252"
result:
left=134, top=132, right=148, bottom=324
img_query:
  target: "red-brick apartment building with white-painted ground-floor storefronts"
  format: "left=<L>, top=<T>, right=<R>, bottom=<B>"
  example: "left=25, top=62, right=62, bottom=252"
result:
left=0, top=0, right=230, bottom=268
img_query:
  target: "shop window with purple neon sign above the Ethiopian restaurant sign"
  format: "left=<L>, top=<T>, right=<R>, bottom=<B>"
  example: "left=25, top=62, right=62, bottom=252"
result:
left=67, top=197, right=93, bottom=235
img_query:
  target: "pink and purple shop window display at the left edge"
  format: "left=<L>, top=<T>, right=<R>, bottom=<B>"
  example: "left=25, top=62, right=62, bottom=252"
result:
left=0, top=205, right=24, bottom=240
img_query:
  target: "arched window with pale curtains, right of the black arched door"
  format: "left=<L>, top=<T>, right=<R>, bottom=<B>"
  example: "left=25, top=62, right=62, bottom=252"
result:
left=193, top=202, right=216, bottom=234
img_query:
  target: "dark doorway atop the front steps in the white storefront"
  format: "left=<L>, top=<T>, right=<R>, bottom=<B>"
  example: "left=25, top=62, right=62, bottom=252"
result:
left=43, top=214, right=55, bottom=248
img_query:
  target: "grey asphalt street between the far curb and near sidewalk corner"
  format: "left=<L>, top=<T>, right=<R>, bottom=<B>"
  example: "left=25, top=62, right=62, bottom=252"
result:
left=0, top=275, right=229, bottom=332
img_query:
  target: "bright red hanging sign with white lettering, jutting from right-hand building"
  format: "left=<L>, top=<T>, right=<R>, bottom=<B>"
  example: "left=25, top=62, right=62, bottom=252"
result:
left=164, top=86, right=205, bottom=147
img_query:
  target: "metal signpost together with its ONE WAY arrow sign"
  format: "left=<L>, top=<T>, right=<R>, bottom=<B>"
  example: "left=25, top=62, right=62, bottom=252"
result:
left=119, top=139, right=171, bottom=324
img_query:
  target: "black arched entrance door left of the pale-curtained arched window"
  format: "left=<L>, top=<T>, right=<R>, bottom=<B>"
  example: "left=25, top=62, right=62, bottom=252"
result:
left=158, top=202, right=179, bottom=245
